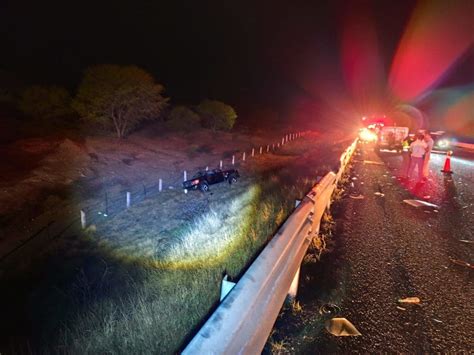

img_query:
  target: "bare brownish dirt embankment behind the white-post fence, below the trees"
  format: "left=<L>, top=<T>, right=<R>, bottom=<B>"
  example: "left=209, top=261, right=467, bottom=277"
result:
left=0, top=127, right=306, bottom=254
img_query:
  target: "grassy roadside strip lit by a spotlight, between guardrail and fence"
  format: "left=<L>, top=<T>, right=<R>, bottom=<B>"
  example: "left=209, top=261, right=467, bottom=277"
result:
left=0, top=135, right=337, bottom=354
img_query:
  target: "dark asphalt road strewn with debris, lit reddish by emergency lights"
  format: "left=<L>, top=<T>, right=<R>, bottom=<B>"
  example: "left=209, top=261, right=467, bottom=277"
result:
left=274, top=146, right=474, bottom=354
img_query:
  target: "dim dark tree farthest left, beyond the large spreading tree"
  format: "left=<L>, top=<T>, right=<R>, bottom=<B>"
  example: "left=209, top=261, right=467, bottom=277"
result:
left=18, top=85, right=73, bottom=119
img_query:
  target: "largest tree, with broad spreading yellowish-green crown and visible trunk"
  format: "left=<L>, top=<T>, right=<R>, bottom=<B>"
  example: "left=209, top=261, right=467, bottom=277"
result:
left=73, top=65, right=168, bottom=138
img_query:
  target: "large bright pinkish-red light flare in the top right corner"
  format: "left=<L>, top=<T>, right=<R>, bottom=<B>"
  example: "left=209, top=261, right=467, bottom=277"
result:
left=389, top=0, right=474, bottom=101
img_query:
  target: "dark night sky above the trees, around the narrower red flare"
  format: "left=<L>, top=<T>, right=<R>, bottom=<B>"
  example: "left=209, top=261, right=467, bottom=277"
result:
left=0, top=0, right=472, bottom=128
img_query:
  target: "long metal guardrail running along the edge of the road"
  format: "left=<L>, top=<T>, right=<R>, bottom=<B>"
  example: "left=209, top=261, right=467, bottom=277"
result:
left=183, top=139, right=357, bottom=355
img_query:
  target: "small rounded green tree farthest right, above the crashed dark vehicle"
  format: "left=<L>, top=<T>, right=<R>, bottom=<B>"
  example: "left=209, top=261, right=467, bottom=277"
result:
left=197, top=100, right=237, bottom=131
